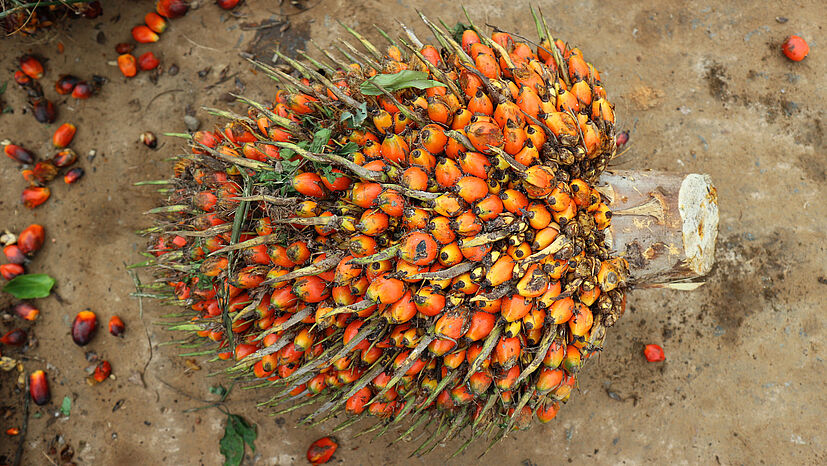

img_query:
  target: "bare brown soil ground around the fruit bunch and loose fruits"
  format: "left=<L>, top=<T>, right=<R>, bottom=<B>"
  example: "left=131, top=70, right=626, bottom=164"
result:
left=0, top=0, right=827, bottom=465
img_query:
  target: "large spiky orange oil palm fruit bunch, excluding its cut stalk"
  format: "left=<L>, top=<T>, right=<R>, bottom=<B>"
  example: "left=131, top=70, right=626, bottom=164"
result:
left=146, top=11, right=628, bottom=452
